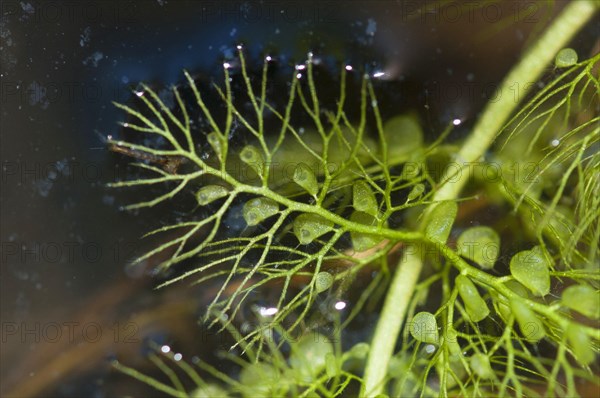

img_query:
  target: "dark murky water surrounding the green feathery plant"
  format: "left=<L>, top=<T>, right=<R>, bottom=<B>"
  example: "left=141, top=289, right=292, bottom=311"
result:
left=0, top=0, right=593, bottom=397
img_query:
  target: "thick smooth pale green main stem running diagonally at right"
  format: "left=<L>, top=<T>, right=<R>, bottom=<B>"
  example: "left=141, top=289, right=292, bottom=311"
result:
left=361, top=0, right=598, bottom=397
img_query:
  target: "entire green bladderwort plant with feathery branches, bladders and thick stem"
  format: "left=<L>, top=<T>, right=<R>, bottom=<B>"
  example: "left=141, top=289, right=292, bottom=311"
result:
left=109, top=1, right=600, bottom=397
